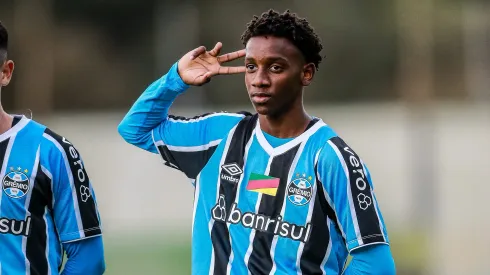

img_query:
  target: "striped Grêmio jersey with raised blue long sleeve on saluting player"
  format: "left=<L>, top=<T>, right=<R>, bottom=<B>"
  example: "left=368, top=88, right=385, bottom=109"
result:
left=119, top=65, right=389, bottom=275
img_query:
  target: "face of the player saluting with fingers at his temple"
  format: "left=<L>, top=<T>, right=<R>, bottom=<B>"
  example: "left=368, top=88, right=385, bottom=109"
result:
left=245, top=36, right=315, bottom=117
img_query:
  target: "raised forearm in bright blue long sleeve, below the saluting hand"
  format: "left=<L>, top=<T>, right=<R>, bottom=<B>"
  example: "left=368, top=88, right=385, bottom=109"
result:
left=118, top=63, right=188, bottom=151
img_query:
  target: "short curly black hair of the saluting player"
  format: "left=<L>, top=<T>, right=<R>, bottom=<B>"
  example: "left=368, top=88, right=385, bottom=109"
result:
left=241, top=9, right=323, bottom=70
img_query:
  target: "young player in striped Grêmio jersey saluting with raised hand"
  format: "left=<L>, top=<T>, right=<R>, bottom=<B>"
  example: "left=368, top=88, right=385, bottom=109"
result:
left=118, top=10, right=395, bottom=275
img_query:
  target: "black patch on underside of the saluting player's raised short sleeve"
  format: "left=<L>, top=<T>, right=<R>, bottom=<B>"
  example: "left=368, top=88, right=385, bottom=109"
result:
left=157, top=144, right=218, bottom=179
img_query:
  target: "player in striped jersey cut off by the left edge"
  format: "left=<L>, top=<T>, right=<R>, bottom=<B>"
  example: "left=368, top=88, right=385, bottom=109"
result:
left=0, top=22, right=105, bottom=275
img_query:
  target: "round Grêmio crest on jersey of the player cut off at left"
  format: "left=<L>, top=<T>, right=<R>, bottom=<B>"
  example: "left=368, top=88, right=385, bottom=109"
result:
left=2, top=167, right=30, bottom=199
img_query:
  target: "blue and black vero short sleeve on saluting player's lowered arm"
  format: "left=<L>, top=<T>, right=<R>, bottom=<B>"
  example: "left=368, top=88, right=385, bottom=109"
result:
left=317, top=137, right=389, bottom=252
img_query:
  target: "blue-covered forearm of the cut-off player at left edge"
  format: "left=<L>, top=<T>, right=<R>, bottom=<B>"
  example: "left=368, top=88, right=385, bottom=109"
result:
left=61, top=236, right=105, bottom=275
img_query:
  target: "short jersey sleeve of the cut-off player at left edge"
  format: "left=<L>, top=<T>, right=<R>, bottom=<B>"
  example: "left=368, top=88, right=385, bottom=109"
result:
left=44, top=129, right=102, bottom=243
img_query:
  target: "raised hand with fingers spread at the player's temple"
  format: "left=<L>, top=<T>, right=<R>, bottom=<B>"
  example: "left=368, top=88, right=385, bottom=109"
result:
left=178, top=42, right=245, bottom=86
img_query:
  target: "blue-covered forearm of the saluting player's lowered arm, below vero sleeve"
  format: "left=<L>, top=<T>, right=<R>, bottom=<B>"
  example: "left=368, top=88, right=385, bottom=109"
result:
left=344, top=244, right=396, bottom=275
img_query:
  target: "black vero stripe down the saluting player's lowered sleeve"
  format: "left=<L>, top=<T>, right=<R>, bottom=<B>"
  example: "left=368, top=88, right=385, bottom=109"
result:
left=330, top=137, right=385, bottom=244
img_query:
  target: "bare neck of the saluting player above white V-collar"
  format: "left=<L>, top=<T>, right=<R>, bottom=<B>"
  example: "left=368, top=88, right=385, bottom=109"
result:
left=259, top=104, right=311, bottom=138
